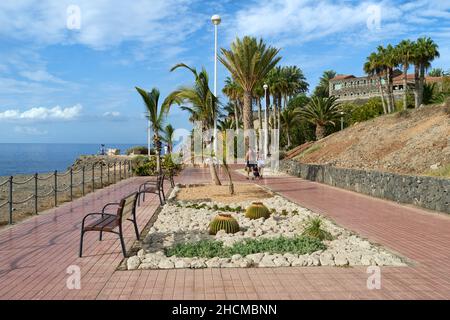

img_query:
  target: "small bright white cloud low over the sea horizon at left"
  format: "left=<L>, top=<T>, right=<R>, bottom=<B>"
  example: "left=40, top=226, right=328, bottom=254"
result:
left=0, top=104, right=82, bottom=121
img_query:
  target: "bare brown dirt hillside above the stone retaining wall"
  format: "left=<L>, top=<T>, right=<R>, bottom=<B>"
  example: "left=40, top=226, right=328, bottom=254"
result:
left=294, top=105, right=450, bottom=176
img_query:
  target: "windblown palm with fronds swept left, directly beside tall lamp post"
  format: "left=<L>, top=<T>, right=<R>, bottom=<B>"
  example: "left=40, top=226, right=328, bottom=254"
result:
left=168, top=63, right=221, bottom=185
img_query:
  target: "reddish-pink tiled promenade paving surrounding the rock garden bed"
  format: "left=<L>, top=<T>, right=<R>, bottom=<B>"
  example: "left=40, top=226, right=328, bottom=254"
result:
left=0, top=169, right=450, bottom=299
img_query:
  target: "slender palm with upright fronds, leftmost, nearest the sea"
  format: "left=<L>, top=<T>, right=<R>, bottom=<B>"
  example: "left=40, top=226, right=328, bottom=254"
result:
left=136, top=87, right=172, bottom=172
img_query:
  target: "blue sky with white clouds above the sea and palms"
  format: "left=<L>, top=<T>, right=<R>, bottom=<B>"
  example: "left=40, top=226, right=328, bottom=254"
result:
left=0, top=0, right=450, bottom=143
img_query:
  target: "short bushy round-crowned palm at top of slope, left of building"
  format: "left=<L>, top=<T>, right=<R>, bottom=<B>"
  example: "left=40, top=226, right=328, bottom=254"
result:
left=300, top=96, right=340, bottom=140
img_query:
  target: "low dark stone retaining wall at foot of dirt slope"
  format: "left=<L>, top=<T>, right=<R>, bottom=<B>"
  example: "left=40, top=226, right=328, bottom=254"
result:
left=280, top=160, right=450, bottom=213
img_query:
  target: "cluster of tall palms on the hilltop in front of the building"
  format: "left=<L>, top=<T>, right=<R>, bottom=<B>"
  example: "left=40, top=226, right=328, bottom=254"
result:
left=364, top=37, right=439, bottom=113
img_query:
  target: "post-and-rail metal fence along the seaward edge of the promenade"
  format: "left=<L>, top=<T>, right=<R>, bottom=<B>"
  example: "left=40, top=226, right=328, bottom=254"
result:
left=0, top=160, right=132, bottom=224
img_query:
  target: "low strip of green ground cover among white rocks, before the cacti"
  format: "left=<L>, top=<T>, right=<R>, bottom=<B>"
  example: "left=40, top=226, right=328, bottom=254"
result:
left=165, top=236, right=326, bottom=258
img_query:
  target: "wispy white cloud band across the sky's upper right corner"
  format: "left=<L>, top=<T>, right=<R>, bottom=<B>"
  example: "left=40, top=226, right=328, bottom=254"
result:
left=227, top=0, right=450, bottom=46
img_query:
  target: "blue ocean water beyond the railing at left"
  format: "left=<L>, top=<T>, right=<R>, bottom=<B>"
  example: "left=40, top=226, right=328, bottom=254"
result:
left=0, top=143, right=145, bottom=176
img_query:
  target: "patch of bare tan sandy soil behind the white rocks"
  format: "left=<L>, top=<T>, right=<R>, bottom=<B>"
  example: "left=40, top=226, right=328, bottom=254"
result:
left=177, top=184, right=273, bottom=204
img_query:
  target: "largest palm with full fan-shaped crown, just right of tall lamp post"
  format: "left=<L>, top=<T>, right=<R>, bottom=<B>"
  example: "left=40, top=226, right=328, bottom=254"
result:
left=219, top=36, right=281, bottom=141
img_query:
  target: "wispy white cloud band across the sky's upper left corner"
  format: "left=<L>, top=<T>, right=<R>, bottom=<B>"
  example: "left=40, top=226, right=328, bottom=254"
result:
left=0, top=0, right=207, bottom=49
